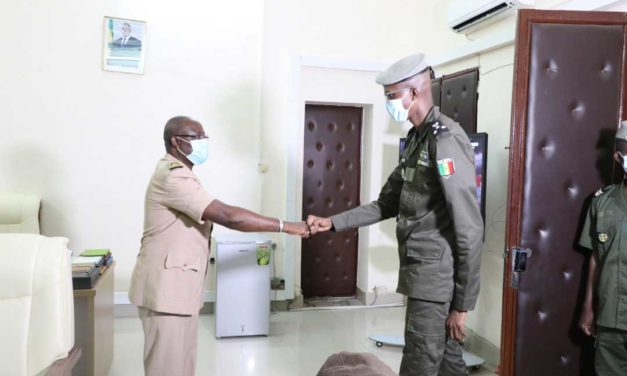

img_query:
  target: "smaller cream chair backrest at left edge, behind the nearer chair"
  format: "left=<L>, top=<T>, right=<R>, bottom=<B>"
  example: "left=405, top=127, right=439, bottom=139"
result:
left=0, top=193, right=41, bottom=234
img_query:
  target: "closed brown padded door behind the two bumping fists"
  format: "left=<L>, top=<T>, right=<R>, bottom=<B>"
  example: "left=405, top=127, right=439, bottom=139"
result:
left=301, top=105, right=362, bottom=297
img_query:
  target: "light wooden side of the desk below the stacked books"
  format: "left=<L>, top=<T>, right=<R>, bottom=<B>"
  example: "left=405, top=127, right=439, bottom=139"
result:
left=72, top=262, right=115, bottom=376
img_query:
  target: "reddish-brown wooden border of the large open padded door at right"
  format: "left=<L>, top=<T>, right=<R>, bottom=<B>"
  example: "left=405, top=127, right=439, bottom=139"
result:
left=497, top=9, right=627, bottom=376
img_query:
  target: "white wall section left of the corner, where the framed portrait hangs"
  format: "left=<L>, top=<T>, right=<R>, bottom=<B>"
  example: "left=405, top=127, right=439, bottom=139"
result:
left=0, top=0, right=263, bottom=291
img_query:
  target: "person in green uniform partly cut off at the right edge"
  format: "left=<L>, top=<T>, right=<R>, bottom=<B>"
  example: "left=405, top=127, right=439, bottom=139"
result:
left=579, top=121, right=627, bottom=376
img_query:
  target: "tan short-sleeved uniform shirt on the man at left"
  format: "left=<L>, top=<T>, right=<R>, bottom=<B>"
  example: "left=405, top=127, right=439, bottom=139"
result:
left=129, top=154, right=213, bottom=315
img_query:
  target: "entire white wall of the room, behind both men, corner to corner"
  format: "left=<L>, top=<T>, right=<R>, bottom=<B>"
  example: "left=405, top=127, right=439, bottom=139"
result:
left=0, top=0, right=627, bottom=352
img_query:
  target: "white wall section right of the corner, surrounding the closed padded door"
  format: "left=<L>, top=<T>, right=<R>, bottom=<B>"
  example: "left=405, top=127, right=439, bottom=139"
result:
left=261, top=0, right=624, bottom=352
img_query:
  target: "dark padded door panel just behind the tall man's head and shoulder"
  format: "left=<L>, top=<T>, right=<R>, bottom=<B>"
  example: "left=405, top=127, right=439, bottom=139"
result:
left=440, top=68, right=479, bottom=133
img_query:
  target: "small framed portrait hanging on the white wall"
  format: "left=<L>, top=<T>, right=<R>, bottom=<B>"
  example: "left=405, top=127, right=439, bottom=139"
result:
left=102, top=17, right=146, bottom=74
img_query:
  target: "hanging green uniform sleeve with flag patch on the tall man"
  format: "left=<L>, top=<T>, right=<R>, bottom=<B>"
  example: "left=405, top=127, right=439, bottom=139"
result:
left=436, top=132, right=483, bottom=311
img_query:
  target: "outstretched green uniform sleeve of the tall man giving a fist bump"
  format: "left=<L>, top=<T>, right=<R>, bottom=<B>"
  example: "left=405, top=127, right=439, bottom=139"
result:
left=331, top=165, right=403, bottom=231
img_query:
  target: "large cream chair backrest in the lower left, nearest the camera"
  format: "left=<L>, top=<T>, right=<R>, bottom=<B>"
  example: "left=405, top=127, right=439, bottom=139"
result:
left=0, top=234, right=74, bottom=376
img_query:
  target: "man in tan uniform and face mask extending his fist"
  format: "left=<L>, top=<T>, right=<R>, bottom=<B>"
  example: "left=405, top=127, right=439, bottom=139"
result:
left=129, top=116, right=309, bottom=376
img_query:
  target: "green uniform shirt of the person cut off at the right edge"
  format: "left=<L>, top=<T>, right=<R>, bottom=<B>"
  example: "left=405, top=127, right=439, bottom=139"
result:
left=579, top=184, right=627, bottom=330
